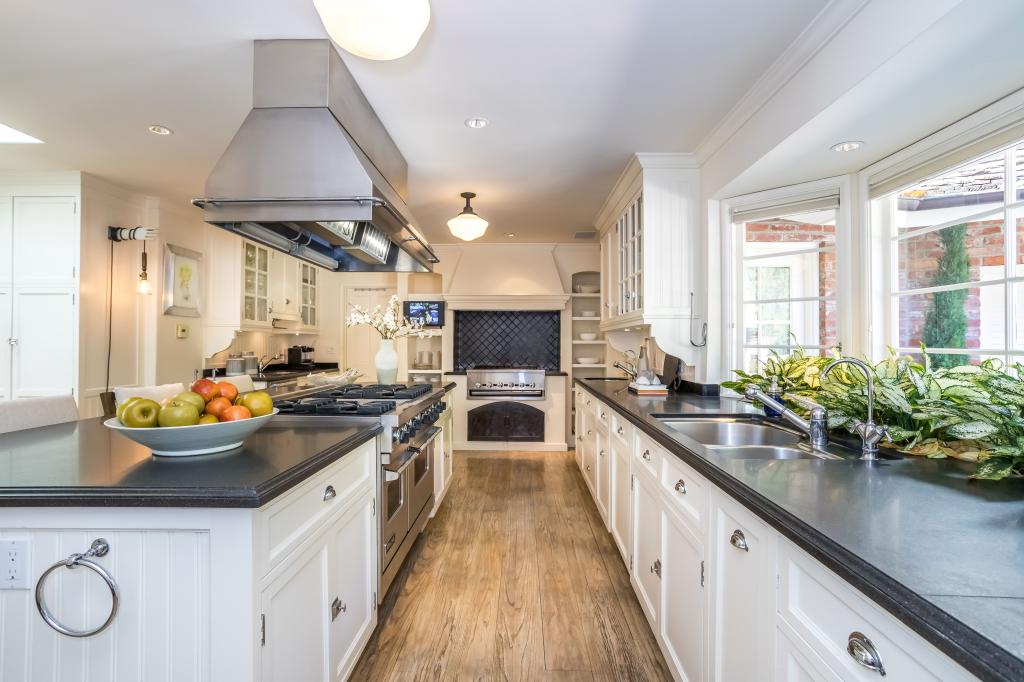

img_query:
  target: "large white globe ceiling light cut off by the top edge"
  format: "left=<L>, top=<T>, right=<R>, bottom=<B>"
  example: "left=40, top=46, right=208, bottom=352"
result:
left=313, top=0, right=430, bottom=60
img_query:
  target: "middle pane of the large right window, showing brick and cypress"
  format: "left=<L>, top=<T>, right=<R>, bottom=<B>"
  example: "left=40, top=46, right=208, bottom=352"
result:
left=897, top=211, right=1006, bottom=291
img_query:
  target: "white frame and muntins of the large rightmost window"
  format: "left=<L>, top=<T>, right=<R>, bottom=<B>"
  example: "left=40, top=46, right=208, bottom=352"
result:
left=870, top=140, right=1024, bottom=363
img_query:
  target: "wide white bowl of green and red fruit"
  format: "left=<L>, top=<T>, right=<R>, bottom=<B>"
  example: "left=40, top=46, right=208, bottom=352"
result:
left=103, top=379, right=278, bottom=457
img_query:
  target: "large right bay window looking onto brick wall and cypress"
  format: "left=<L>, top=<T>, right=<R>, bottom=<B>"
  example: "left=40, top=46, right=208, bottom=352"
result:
left=876, top=143, right=1024, bottom=367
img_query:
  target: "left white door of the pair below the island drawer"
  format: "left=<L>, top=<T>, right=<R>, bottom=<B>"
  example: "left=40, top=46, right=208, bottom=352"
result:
left=260, top=536, right=334, bottom=682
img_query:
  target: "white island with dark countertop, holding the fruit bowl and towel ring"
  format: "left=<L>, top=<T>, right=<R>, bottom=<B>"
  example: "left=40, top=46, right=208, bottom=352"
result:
left=0, top=416, right=381, bottom=682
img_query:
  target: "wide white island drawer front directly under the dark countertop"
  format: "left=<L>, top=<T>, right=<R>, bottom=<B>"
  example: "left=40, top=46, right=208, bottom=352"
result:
left=255, top=438, right=380, bottom=576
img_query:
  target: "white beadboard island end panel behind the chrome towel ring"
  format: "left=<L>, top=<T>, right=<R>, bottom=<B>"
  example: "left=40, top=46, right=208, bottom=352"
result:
left=0, top=529, right=210, bottom=682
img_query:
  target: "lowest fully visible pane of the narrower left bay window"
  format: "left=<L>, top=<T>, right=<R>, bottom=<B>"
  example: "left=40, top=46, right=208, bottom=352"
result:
left=743, top=299, right=839, bottom=347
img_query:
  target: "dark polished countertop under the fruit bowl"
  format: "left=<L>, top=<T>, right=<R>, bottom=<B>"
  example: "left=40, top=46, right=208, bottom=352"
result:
left=0, top=417, right=381, bottom=507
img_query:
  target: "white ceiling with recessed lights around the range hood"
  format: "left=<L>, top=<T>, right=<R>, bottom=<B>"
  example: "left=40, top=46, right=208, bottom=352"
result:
left=0, top=0, right=825, bottom=242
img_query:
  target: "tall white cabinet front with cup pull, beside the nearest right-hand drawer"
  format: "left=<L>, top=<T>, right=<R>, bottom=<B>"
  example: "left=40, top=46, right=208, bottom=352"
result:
left=709, top=495, right=775, bottom=682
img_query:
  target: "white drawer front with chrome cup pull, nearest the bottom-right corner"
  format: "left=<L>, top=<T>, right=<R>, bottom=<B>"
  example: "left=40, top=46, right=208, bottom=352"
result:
left=778, top=541, right=975, bottom=682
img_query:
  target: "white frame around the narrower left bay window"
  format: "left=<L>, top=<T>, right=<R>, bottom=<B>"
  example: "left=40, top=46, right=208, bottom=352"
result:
left=719, top=175, right=862, bottom=376
